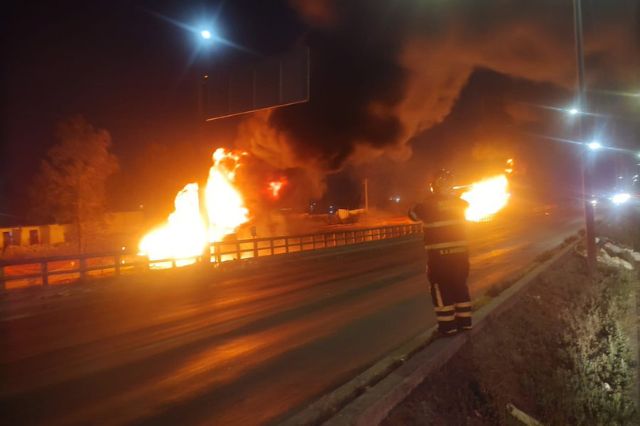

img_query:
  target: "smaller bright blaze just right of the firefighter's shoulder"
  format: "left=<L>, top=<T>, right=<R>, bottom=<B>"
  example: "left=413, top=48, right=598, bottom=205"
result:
left=460, top=175, right=511, bottom=222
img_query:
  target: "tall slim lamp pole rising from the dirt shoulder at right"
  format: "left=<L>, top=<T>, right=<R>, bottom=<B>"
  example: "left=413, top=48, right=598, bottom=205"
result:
left=573, top=0, right=596, bottom=276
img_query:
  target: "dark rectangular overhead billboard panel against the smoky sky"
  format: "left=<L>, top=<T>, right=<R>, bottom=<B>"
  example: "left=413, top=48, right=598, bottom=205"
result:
left=203, top=47, right=309, bottom=121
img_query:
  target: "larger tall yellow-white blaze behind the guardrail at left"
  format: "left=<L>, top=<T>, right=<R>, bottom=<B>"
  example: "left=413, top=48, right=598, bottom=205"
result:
left=139, top=148, right=249, bottom=268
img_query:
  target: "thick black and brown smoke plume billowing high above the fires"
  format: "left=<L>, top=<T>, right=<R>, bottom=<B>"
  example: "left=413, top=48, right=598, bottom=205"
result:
left=239, top=0, right=637, bottom=190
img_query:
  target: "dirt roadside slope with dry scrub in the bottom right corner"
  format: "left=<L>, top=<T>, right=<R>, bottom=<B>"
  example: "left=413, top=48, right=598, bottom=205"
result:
left=383, top=245, right=640, bottom=425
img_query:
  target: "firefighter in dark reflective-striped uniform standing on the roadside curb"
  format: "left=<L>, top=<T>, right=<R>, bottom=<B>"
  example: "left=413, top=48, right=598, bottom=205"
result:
left=409, top=170, right=471, bottom=336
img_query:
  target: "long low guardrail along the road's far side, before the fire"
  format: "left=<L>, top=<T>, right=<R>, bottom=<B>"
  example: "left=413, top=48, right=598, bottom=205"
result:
left=0, top=224, right=422, bottom=290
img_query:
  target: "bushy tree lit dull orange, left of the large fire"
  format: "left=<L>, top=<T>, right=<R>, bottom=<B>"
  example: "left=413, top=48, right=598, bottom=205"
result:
left=31, top=116, right=118, bottom=251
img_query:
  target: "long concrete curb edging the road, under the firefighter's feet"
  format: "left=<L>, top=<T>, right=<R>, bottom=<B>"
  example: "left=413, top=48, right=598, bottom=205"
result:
left=282, top=240, right=575, bottom=426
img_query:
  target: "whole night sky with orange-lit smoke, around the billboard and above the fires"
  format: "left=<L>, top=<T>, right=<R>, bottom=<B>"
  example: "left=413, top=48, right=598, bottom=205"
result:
left=0, top=0, right=640, bottom=226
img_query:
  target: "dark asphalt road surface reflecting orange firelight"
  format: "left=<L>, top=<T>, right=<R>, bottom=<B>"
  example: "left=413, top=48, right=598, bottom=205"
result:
left=0, top=212, right=581, bottom=425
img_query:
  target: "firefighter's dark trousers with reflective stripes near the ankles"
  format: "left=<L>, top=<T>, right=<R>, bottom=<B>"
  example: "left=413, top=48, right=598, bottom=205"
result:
left=428, top=247, right=471, bottom=334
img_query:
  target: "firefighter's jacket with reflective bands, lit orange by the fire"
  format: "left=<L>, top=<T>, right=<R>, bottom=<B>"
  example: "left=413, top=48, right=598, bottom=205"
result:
left=409, top=194, right=468, bottom=255
